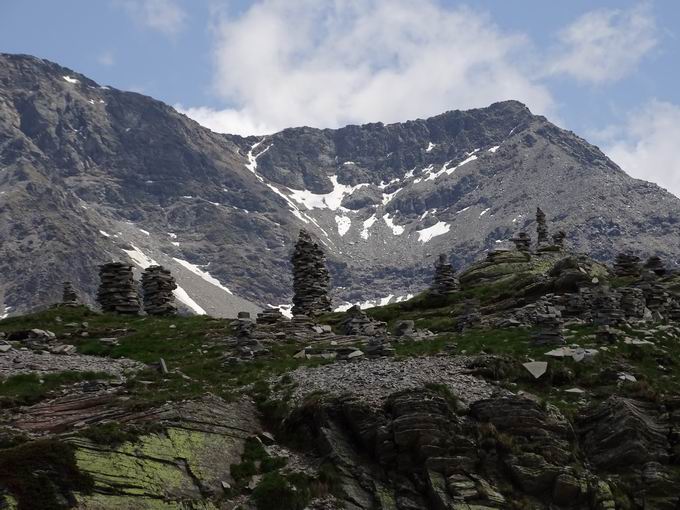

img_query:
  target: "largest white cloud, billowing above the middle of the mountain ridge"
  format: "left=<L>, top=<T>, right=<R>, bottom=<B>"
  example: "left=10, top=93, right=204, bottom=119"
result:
left=179, top=0, right=553, bottom=134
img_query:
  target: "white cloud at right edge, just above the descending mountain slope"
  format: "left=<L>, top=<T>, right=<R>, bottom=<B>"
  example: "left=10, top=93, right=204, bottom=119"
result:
left=605, top=101, right=680, bottom=197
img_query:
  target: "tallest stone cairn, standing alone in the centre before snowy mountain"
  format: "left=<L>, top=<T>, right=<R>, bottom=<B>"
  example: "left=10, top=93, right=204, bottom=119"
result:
left=293, top=230, right=331, bottom=316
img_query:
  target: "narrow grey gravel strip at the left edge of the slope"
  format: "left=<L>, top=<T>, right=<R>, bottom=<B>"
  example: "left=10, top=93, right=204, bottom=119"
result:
left=0, top=349, right=144, bottom=378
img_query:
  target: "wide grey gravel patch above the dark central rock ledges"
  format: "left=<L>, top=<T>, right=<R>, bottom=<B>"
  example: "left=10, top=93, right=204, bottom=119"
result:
left=278, top=356, right=500, bottom=405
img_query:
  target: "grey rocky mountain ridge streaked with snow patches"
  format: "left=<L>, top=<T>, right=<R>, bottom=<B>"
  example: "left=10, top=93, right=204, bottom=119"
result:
left=0, top=55, right=680, bottom=316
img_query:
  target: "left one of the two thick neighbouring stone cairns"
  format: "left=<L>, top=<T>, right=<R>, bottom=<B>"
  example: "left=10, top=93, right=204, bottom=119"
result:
left=97, top=262, right=139, bottom=315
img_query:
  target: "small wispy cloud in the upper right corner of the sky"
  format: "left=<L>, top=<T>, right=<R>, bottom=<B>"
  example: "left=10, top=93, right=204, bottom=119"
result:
left=546, top=3, right=657, bottom=84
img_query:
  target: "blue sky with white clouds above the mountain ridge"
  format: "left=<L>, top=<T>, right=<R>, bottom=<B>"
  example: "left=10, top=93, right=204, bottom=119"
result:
left=0, top=0, right=680, bottom=194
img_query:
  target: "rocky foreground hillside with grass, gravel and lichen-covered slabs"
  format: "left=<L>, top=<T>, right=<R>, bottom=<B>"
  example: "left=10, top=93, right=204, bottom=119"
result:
left=0, top=247, right=680, bottom=510
